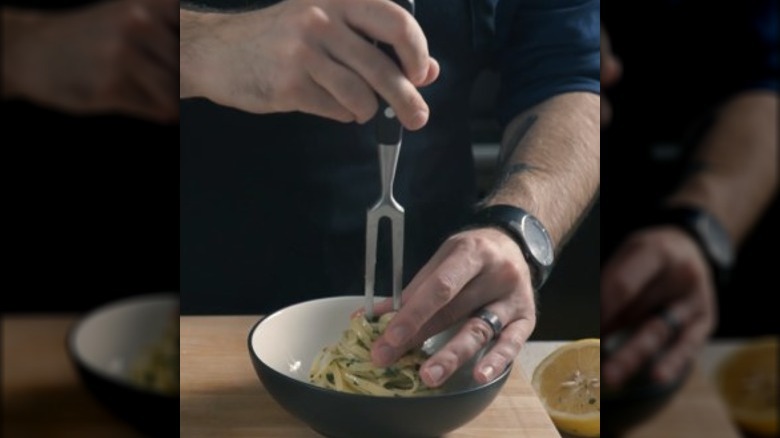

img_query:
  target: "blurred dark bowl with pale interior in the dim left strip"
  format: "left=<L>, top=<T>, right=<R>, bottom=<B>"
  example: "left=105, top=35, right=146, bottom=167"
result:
left=67, top=293, right=179, bottom=436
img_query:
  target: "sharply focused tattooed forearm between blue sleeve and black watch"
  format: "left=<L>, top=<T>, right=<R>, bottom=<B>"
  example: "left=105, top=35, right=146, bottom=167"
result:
left=483, top=93, right=601, bottom=246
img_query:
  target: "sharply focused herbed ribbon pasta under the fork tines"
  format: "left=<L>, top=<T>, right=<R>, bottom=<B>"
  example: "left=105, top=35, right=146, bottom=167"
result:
left=309, top=313, right=435, bottom=397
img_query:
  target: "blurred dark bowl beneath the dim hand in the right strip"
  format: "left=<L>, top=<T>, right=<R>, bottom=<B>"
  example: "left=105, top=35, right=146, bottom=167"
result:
left=601, top=330, right=692, bottom=438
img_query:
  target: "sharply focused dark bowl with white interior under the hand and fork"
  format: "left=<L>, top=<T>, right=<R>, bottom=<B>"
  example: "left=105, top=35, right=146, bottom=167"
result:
left=248, top=296, right=511, bottom=438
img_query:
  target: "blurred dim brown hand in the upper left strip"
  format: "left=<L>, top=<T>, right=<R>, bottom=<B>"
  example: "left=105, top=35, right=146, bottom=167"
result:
left=3, top=0, right=179, bottom=122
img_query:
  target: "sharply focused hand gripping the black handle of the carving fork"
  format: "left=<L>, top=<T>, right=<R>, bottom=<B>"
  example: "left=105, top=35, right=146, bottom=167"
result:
left=181, top=0, right=439, bottom=130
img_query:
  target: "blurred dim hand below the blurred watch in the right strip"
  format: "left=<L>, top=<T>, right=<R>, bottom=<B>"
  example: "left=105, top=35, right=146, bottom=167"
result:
left=601, top=227, right=717, bottom=387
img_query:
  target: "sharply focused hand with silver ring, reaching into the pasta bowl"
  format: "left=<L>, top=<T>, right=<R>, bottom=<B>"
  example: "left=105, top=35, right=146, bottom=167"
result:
left=371, top=228, right=536, bottom=387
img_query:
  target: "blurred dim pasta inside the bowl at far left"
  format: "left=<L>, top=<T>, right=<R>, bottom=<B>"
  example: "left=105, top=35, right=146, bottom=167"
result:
left=130, top=314, right=179, bottom=395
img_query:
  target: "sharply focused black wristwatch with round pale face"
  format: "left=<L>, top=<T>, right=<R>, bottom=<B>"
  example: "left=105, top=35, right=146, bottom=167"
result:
left=468, top=205, right=555, bottom=290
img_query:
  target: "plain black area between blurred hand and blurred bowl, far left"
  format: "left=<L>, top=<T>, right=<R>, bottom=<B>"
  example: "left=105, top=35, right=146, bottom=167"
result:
left=0, top=102, right=179, bottom=312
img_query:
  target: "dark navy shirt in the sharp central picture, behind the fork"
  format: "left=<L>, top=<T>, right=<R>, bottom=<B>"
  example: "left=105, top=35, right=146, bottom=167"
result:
left=180, top=0, right=599, bottom=313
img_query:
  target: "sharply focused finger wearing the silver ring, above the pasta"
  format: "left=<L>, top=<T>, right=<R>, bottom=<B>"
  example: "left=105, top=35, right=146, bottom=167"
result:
left=420, top=304, right=509, bottom=388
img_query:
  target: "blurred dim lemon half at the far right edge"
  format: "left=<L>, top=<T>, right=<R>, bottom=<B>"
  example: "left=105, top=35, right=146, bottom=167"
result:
left=715, top=338, right=778, bottom=437
